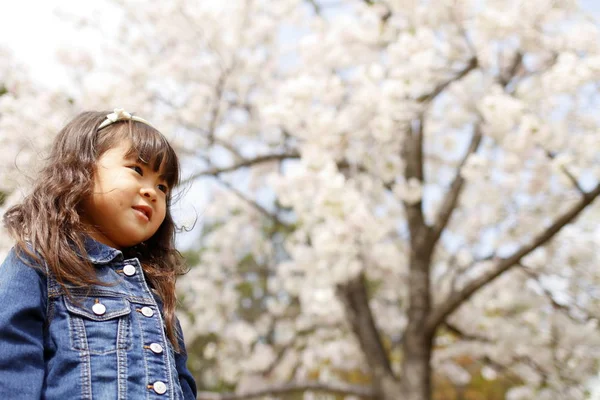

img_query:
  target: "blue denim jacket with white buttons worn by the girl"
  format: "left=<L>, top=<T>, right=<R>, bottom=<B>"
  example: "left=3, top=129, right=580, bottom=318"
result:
left=0, top=240, right=196, bottom=400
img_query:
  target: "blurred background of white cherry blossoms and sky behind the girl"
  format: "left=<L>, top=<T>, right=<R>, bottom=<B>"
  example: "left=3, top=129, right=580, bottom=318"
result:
left=0, top=0, right=600, bottom=400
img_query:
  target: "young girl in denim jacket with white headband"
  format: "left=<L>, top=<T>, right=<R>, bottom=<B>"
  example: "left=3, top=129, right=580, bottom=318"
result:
left=0, top=109, right=196, bottom=400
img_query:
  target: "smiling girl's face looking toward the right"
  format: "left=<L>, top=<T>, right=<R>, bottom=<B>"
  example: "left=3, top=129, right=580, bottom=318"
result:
left=81, top=141, right=169, bottom=249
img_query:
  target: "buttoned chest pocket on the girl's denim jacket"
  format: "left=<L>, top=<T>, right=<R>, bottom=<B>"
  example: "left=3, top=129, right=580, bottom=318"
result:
left=64, top=297, right=131, bottom=354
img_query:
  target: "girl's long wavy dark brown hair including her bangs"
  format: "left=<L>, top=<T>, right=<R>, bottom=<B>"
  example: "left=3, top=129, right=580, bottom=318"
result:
left=4, top=111, right=186, bottom=351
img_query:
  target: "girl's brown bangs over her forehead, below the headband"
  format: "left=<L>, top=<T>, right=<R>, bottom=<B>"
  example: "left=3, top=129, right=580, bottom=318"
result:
left=107, top=121, right=179, bottom=189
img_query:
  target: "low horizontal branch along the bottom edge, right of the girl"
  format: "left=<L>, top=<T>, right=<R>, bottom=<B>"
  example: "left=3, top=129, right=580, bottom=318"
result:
left=197, top=382, right=374, bottom=400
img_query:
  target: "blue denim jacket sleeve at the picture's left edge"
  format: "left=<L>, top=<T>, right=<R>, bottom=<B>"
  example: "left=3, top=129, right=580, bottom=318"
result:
left=0, top=248, right=48, bottom=399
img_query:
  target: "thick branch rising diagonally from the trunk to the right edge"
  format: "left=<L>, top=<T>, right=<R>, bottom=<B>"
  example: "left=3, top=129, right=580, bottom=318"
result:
left=427, top=184, right=600, bottom=329
